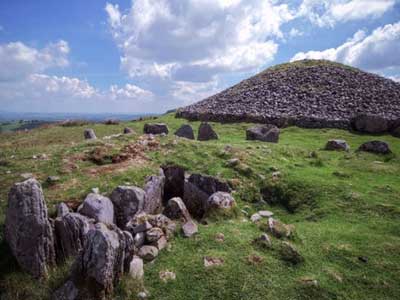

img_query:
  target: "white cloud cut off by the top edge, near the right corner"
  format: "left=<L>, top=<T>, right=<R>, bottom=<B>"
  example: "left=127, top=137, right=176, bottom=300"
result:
left=297, top=0, right=396, bottom=27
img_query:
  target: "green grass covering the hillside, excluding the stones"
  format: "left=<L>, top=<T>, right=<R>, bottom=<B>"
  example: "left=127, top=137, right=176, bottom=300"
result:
left=0, top=114, right=400, bottom=300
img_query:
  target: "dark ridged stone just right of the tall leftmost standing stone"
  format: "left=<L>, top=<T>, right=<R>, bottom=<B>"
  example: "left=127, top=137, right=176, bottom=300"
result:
left=54, top=213, right=94, bottom=261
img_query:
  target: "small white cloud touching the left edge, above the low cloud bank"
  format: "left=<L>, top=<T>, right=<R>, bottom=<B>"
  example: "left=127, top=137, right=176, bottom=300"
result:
left=0, top=40, right=69, bottom=81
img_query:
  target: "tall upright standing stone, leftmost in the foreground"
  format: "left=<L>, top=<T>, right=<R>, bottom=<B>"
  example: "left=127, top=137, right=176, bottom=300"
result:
left=5, top=178, right=55, bottom=278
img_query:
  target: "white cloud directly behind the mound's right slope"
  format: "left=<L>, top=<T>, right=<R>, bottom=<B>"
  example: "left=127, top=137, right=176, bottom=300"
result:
left=291, top=22, right=400, bottom=71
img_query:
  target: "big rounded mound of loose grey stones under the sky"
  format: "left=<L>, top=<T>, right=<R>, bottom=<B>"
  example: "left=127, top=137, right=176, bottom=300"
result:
left=177, top=60, right=400, bottom=129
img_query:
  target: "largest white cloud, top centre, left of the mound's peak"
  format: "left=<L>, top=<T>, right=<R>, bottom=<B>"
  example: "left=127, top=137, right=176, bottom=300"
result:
left=106, top=0, right=293, bottom=82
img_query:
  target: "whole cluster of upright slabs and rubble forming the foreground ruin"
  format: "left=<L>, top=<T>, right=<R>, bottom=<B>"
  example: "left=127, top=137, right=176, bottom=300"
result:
left=5, top=166, right=235, bottom=300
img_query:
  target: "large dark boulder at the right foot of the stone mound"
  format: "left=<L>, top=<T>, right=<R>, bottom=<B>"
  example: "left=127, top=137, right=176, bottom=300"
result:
left=350, top=114, right=390, bottom=133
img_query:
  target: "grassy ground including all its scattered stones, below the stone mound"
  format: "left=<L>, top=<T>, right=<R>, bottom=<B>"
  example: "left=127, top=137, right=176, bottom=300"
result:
left=0, top=114, right=400, bottom=300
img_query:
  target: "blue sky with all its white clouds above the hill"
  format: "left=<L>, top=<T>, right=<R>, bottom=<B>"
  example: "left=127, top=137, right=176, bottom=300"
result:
left=0, top=0, right=400, bottom=113
